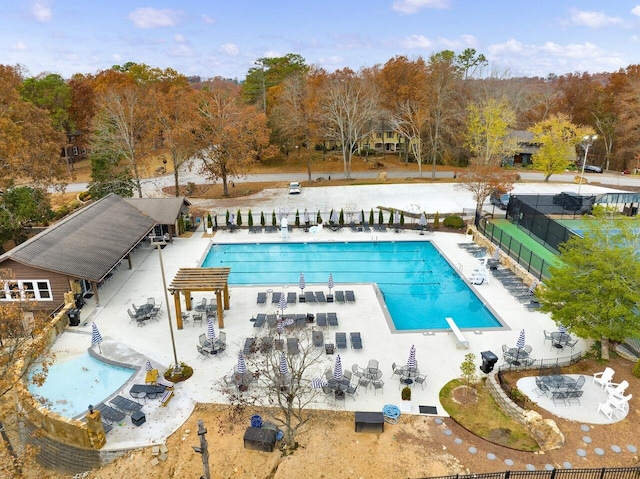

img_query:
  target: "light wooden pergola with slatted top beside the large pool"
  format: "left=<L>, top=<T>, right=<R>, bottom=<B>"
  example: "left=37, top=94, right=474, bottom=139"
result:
left=167, top=268, right=231, bottom=329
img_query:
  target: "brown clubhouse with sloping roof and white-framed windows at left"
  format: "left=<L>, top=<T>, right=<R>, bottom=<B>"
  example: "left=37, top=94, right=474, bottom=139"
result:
left=0, top=194, right=188, bottom=312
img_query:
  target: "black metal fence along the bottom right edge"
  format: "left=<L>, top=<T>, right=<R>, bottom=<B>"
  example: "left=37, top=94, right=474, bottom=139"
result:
left=422, top=466, right=640, bottom=479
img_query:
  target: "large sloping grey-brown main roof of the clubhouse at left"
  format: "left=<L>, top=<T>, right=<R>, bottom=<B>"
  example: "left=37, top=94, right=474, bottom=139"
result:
left=0, top=194, right=156, bottom=282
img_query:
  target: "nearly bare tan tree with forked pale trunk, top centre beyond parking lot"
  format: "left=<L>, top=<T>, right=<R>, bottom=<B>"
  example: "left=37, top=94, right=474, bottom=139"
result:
left=321, top=69, right=378, bottom=178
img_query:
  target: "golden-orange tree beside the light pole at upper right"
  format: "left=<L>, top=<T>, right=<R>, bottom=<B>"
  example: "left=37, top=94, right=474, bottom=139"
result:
left=530, top=114, right=594, bottom=181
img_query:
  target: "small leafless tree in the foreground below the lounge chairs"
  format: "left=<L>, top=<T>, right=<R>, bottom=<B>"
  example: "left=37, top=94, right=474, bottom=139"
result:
left=223, top=326, right=330, bottom=448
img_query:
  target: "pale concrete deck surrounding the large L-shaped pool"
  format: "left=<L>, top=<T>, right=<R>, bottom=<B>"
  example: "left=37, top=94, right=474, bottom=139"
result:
left=41, top=185, right=616, bottom=450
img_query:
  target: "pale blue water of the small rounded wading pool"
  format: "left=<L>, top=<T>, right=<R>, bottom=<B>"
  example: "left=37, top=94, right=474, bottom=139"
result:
left=29, top=353, right=135, bottom=418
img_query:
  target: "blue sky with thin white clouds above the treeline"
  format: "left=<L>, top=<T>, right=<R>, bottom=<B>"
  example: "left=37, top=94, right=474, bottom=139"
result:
left=0, top=0, right=640, bottom=80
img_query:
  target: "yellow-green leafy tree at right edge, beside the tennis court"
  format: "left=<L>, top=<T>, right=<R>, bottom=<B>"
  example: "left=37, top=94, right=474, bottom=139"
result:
left=538, top=214, right=640, bottom=359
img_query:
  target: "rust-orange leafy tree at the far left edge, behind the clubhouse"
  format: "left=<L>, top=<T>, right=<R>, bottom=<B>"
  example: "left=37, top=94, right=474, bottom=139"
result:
left=0, top=65, right=66, bottom=188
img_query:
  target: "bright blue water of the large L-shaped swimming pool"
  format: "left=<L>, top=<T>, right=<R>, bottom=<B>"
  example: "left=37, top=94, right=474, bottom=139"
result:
left=202, top=241, right=502, bottom=330
